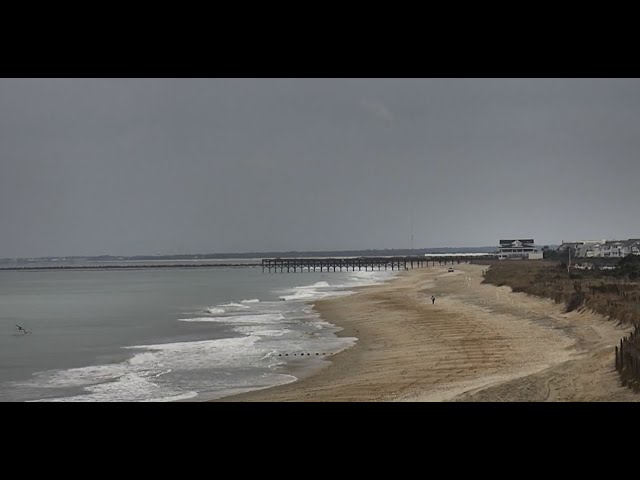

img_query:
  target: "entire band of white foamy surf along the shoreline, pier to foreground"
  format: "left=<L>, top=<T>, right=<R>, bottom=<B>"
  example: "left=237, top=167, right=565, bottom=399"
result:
left=27, top=272, right=395, bottom=402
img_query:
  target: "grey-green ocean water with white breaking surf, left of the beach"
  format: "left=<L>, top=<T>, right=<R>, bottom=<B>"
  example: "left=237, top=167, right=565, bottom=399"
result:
left=0, top=267, right=396, bottom=401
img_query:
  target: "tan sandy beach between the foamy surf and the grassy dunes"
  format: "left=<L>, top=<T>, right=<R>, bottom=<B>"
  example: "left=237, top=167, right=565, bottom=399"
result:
left=217, top=264, right=640, bottom=402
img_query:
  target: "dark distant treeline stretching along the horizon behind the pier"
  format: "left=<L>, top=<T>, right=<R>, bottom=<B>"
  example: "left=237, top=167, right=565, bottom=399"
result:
left=0, top=246, right=496, bottom=263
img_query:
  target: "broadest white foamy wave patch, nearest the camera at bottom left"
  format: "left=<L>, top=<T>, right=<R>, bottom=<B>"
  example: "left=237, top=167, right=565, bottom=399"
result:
left=16, top=331, right=291, bottom=402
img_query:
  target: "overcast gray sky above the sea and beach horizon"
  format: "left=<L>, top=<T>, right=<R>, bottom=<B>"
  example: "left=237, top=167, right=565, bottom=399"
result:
left=0, top=79, right=640, bottom=257
